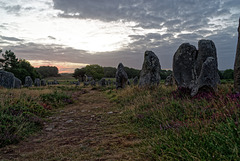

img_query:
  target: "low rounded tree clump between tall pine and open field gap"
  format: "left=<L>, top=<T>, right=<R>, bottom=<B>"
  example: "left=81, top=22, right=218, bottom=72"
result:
left=36, top=66, right=60, bottom=78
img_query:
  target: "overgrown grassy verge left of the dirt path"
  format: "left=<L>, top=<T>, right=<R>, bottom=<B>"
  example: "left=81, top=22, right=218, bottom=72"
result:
left=0, top=88, right=73, bottom=147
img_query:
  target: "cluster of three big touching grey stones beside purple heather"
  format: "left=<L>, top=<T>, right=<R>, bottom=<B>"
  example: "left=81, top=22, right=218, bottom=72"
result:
left=173, top=40, right=220, bottom=96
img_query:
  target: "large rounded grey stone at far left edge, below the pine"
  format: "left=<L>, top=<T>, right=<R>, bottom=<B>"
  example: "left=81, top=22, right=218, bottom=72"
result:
left=0, top=70, right=15, bottom=88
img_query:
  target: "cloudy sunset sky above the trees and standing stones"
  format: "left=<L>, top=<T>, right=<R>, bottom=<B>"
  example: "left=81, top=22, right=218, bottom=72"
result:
left=0, top=0, right=240, bottom=73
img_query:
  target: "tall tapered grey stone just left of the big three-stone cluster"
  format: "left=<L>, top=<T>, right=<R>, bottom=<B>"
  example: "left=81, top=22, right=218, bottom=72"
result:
left=139, top=51, right=161, bottom=87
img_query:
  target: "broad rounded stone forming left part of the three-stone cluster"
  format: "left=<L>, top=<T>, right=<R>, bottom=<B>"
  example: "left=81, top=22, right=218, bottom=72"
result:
left=173, top=43, right=197, bottom=89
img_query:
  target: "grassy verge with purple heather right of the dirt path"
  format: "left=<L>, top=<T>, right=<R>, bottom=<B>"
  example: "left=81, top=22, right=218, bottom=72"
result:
left=107, top=84, right=240, bottom=160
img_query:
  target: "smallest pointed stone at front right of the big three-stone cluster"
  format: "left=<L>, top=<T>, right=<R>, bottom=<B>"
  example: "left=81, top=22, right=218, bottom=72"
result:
left=191, top=57, right=220, bottom=96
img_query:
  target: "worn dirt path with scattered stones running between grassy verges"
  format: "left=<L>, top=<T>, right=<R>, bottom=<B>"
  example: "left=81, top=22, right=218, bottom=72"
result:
left=0, top=90, right=142, bottom=161
